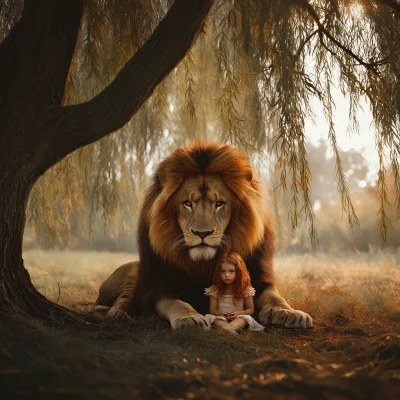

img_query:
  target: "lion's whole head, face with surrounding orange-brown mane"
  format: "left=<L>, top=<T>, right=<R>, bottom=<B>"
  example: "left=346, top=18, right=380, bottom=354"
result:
left=145, top=144, right=265, bottom=269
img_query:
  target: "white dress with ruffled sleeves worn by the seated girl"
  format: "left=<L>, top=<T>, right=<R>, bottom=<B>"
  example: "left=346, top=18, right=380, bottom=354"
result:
left=204, top=286, right=264, bottom=332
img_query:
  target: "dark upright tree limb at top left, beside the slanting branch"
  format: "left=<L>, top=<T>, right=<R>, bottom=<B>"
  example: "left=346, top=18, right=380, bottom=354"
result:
left=0, top=0, right=84, bottom=131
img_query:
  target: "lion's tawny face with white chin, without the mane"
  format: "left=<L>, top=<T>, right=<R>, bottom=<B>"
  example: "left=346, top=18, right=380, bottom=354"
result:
left=174, top=177, right=233, bottom=261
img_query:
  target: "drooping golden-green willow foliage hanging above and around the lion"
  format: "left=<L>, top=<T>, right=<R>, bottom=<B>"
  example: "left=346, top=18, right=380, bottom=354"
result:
left=0, top=0, right=400, bottom=242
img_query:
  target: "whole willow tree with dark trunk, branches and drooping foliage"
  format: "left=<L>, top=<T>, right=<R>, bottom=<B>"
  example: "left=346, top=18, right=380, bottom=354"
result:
left=0, top=0, right=400, bottom=318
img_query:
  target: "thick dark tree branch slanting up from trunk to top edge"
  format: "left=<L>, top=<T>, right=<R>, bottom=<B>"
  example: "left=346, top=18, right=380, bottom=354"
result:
left=40, top=0, right=213, bottom=169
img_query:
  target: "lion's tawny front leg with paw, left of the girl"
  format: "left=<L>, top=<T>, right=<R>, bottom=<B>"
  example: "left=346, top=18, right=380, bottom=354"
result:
left=156, top=298, right=210, bottom=330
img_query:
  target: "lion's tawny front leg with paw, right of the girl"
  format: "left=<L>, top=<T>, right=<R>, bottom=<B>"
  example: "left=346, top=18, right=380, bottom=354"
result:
left=256, top=287, right=312, bottom=328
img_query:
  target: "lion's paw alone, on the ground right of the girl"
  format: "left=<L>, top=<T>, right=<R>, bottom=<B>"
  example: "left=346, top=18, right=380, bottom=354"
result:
left=259, top=307, right=313, bottom=328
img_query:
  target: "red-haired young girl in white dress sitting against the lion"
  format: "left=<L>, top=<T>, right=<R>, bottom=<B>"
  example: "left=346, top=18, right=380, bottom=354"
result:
left=204, top=251, right=264, bottom=333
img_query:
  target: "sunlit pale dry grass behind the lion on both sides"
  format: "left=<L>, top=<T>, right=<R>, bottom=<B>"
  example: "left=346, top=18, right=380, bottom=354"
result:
left=24, top=250, right=400, bottom=321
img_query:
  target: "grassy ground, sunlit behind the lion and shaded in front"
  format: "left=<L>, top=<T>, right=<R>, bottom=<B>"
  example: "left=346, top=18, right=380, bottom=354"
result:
left=0, top=250, right=400, bottom=400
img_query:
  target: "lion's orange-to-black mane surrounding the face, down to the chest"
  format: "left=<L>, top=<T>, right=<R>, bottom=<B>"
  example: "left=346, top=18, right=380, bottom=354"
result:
left=134, top=143, right=274, bottom=312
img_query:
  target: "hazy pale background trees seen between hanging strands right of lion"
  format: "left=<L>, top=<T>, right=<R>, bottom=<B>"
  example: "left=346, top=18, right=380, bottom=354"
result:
left=273, top=140, right=400, bottom=254
